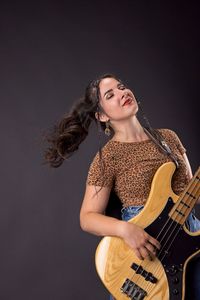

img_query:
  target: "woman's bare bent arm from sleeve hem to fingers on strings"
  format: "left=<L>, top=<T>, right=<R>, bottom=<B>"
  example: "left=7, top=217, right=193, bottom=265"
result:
left=80, top=185, right=160, bottom=259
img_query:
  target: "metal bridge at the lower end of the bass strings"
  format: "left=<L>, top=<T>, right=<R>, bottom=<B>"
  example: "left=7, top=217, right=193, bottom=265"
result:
left=121, top=278, right=147, bottom=300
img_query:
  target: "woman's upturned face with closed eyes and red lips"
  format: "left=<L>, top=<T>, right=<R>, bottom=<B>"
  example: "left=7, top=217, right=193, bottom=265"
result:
left=99, top=78, right=138, bottom=123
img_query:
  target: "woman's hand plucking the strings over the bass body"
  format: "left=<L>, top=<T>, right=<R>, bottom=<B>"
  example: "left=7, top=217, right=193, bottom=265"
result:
left=121, top=222, right=160, bottom=260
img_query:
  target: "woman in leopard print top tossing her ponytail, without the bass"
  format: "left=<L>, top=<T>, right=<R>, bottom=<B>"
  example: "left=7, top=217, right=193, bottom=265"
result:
left=45, top=74, right=200, bottom=299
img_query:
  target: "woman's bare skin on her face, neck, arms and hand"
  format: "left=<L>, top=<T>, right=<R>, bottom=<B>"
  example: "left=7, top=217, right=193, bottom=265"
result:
left=80, top=78, right=198, bottom=260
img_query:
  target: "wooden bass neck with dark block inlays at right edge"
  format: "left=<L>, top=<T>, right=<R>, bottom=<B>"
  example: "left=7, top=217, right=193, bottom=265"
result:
left=169, top=167, right=200, bottom=225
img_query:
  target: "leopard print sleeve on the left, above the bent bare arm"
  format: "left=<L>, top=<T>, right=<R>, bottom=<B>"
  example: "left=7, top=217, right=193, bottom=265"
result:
left=86, top=152, right=115, bottom=187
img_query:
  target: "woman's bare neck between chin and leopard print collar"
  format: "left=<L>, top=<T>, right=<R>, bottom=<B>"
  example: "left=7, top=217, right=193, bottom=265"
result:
left=112, top=116, right=148, bottom=142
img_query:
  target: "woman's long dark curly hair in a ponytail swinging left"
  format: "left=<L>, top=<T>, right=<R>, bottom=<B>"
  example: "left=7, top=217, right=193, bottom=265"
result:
left=44, top=74, right=121, bottom=168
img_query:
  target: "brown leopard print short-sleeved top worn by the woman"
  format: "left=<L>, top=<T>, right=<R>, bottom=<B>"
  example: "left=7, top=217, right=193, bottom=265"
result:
left=87, top=129, right=189, bottom=207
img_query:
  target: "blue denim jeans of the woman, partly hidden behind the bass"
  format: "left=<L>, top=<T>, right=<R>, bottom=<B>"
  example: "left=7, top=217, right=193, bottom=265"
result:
left=109, top=206, right=200, bottom=300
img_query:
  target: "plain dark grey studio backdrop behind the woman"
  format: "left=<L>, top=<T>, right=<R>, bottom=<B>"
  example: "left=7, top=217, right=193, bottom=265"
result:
left=0, top=0, right=200, bottom=300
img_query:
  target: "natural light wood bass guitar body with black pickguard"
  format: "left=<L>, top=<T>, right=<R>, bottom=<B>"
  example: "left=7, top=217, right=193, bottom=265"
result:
left=95, top=162, right=200, bottom=300
